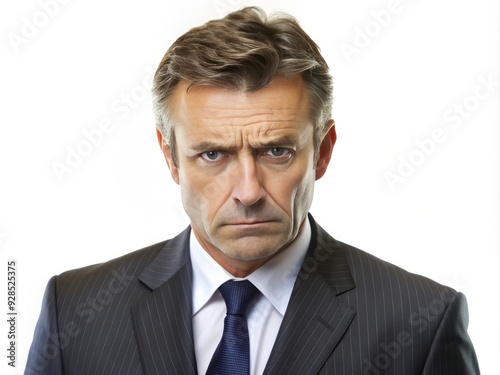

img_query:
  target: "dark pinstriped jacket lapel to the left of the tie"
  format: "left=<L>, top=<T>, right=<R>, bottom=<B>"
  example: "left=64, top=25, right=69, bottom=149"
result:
left=132, top=229, right=196, bottom=374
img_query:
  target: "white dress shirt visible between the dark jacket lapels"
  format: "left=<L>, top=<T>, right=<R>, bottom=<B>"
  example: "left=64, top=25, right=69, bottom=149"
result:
left=190, top=218, right=311, bottom=375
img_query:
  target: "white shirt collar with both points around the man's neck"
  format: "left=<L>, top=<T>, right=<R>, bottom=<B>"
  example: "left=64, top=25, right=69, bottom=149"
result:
left=189, top=218, right=311, bottom=316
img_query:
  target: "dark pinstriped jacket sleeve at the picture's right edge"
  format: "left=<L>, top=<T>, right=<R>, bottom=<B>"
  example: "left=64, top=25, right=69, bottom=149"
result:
left=423, top=293, right=480, bottom=375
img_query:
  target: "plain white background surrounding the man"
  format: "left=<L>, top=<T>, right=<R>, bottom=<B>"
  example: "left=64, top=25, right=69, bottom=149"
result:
left=0, top=0, right=500, bottom=374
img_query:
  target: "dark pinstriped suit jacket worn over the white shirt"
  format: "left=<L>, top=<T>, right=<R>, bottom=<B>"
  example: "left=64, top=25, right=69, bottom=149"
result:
left=26, top=217, right=479, bottom=375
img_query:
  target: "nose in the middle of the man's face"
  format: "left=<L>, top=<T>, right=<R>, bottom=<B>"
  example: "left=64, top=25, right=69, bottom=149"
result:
left=233, top=156, right=265, bottom=206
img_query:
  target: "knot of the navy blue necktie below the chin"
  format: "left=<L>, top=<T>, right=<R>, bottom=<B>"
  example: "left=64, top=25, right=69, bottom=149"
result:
left=219, top=280, right=259, bottom=315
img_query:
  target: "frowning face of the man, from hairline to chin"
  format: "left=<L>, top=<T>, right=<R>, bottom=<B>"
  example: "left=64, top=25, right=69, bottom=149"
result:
left=158, top=77, right=334, bottom=275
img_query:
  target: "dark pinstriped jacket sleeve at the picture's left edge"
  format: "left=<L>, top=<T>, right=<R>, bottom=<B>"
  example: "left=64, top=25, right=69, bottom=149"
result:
left=24, top=276, right=64, bottom=375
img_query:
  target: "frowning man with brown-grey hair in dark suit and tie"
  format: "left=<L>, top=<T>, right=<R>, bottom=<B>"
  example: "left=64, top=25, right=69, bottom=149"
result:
left=27, top=8, right=479, bottom=375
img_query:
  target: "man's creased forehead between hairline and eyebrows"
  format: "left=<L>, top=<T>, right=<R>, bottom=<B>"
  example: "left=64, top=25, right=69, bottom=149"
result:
left=174, top=78, right=313, bottom=147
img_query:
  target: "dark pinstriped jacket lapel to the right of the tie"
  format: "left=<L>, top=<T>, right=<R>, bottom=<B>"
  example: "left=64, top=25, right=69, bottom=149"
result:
left=264, top=217, right=356, bottom=374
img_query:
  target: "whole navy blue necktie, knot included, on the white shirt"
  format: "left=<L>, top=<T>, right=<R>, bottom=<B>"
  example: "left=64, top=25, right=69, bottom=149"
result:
left=207, top=280, right=259, bottom=375
